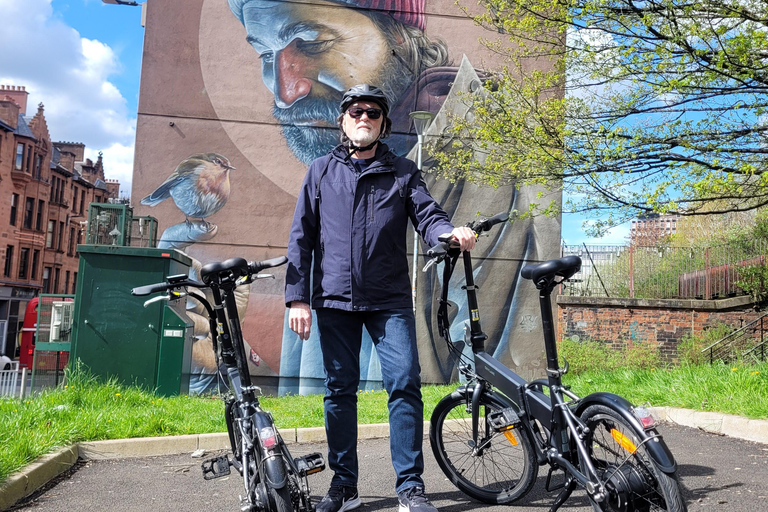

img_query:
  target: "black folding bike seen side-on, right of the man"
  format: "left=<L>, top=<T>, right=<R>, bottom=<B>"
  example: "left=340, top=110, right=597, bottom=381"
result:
left=425, top=214, right=687, bottom=512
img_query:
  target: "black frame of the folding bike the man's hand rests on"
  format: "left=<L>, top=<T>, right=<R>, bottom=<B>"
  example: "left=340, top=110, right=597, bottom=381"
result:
left=438, top=239, right=676, bottom=511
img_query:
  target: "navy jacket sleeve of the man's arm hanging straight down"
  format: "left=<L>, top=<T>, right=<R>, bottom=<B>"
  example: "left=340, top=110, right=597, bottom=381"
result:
left=285, top=163, right=319, bottom=306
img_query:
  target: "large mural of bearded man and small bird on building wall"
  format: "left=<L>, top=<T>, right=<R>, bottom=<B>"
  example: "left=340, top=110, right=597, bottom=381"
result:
left=133, top=0, right=560, bottom=392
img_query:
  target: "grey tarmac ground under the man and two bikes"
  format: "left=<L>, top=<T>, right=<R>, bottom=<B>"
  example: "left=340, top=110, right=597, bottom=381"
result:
left=15, top=424, right=768, bottom=512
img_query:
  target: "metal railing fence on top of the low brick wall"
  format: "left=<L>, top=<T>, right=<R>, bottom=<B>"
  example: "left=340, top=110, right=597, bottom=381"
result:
left=562, top=242, right=768, bottom=299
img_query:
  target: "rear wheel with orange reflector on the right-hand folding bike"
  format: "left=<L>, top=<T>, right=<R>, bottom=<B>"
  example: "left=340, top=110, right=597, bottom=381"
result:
left=581, top=405, right=687, bottom=512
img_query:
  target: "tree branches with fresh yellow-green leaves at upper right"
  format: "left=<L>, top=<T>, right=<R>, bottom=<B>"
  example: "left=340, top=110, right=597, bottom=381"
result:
left=428, top=0, right=768, bottom=233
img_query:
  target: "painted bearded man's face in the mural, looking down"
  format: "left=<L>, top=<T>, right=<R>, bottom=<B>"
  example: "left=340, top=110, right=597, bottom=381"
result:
left=243, top=0, right=413, bottom=163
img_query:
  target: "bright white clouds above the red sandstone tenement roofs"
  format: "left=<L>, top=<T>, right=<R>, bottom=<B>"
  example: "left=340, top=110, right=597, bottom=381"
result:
left=0, top=0, right=136, bottom=191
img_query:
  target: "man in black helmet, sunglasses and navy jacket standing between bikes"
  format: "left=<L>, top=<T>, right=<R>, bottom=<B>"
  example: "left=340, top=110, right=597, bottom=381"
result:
left=285, top=84, right=475, bottom=512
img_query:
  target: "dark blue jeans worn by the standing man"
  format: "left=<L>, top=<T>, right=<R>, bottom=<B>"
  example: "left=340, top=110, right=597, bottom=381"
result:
left=316, top=308, right=424, bottom=493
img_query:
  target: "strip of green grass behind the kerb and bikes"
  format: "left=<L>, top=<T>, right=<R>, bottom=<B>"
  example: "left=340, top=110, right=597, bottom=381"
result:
left=0, top=363, right=768, bottom=483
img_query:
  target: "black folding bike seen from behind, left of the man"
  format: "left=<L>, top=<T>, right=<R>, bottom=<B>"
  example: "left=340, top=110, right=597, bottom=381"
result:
left=132, top=256, right=325, bottom=512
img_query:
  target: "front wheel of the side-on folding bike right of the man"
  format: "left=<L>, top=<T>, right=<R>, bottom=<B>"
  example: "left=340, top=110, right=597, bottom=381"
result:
left=429, top=391, right=539, bottom=504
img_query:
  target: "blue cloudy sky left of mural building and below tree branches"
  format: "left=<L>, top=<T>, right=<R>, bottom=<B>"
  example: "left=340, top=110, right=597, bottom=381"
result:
left=0, top=0, right=628, bottom=244
